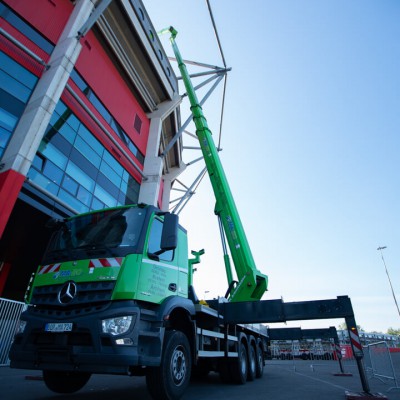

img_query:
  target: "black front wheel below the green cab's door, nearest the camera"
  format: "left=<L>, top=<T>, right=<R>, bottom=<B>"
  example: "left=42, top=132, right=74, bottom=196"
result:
left=146, top=331, right=192, bottom=400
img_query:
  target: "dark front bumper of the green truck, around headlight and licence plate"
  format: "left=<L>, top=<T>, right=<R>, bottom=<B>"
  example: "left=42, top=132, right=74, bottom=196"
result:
left=9, top=301, right=163, bottom=374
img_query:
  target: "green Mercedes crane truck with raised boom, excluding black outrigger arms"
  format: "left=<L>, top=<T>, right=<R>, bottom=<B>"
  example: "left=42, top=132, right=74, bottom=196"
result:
left=10, top=28, right=268, bottom=399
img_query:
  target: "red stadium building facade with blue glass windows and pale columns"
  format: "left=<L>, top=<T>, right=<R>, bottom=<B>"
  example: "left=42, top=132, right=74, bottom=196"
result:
left=0, top=0, right=181, bottom=300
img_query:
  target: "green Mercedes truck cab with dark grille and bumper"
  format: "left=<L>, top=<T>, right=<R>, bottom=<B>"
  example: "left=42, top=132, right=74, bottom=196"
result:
left=10, top=205, right=200, bottom=392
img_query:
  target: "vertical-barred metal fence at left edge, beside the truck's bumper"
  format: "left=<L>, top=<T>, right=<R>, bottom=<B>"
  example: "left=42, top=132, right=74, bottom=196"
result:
left=0, top=297, right=27, bottom=366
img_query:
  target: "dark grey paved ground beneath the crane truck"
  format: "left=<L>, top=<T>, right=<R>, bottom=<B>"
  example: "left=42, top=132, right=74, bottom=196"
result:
left=0, top=353, right=400, bottom=400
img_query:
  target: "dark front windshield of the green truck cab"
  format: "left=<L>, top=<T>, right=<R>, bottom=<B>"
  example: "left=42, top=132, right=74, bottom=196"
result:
left=47, top=208, right=146, bottom=254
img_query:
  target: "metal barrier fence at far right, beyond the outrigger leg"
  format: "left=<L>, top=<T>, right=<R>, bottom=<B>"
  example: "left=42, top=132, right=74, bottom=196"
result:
left=364, top=342, right=400, bottom=390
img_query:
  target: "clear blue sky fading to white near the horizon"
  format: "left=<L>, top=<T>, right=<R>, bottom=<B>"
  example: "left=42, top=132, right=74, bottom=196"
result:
left=145, top=0, right=400, bottom=332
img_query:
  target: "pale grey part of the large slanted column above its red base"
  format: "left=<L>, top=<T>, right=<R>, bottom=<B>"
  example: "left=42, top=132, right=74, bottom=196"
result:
left=2, top=0, right=93, bottom=176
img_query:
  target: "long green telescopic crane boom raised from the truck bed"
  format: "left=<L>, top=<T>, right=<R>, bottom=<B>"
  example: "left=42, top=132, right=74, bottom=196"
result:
left=162, top=27, right=268, bottom=302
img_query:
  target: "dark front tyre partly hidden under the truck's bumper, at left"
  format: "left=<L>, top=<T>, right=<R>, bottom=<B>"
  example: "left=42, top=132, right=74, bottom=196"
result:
left=43, top=370, right=91, bottom=393
